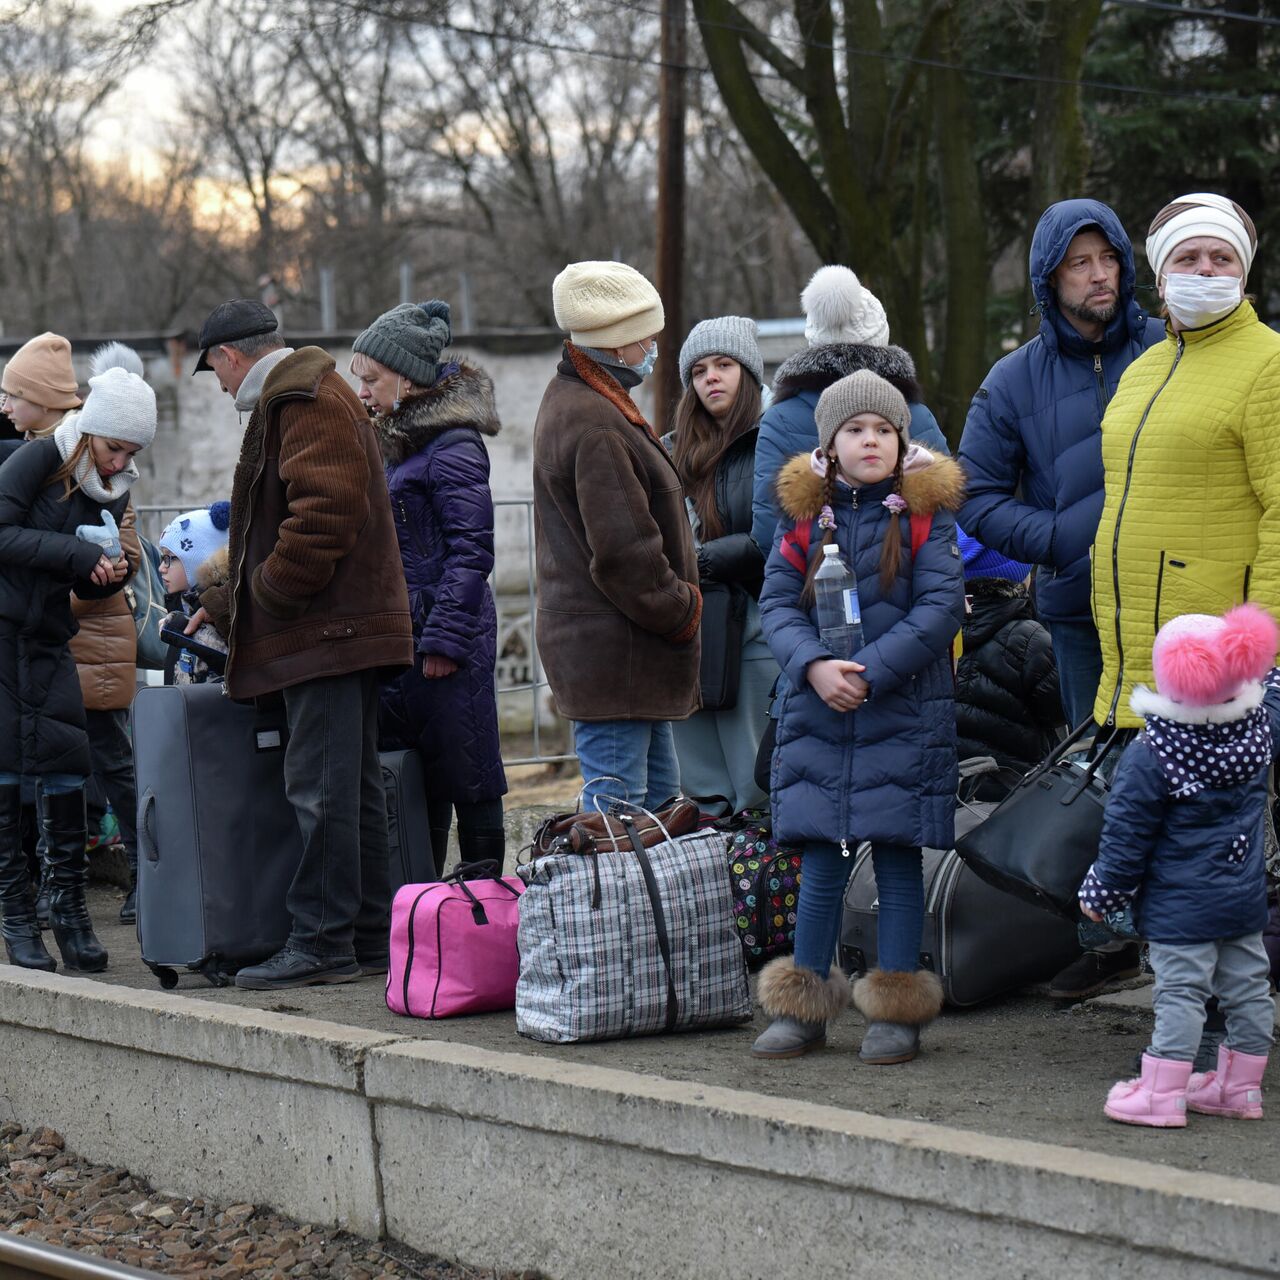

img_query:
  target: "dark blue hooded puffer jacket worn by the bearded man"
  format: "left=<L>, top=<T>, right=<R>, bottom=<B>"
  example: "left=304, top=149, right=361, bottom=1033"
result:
left=959, top=200, right=1165, bottom=622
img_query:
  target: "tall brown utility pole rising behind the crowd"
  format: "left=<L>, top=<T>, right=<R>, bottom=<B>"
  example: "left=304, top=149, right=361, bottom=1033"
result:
left=653, top=0, right=687, bottom=431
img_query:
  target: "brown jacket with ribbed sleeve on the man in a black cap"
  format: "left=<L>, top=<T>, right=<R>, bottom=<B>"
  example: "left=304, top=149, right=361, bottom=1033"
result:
left=200, top=347, right=413, bottom=699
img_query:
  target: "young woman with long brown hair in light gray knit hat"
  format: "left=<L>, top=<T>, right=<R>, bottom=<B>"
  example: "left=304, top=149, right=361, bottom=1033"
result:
left=663, top=316, right=778, bottom=813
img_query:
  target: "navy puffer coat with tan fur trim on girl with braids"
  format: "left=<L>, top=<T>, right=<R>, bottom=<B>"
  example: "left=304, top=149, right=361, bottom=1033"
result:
left=760, top=451, right=964, bottom=849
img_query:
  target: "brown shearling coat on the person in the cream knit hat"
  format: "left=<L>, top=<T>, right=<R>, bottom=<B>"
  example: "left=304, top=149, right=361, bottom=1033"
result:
left=534, top=343, right=703, bottom=721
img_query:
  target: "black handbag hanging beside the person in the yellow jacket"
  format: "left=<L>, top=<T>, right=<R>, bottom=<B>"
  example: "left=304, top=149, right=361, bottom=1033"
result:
left=956, top=721, right=1126, bottom=920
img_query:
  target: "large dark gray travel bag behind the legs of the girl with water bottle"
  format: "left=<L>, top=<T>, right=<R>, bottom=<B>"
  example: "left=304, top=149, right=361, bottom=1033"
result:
left=838, top=760, right=1080, bottom=1006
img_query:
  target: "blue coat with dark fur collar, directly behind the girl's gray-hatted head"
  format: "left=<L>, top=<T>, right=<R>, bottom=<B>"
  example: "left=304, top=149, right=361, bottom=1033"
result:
left=751, top=342, right=951, bottom=557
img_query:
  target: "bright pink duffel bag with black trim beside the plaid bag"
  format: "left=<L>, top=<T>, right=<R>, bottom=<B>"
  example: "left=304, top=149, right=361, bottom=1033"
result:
left=387, top=861, right=525, bottom=1018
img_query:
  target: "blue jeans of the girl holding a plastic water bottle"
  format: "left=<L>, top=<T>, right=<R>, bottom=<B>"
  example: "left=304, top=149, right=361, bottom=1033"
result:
left=795, top=841, right=924, bottom=978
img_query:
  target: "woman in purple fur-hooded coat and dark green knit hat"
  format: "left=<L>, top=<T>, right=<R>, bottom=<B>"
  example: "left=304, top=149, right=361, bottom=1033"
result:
left=351, top=301, right=507, bottom=868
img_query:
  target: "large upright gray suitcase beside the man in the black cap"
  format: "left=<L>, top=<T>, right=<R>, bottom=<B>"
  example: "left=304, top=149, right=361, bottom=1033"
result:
left=133, top=684, right=302, bottom=988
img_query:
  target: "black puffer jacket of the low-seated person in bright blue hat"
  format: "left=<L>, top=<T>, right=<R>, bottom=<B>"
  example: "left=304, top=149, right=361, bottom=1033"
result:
left=956, top=577, right=1064, bottom=772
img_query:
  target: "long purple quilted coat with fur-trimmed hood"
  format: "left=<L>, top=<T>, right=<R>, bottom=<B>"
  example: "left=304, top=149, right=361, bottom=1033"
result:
left=376, top=364, right=507, bottom=801
